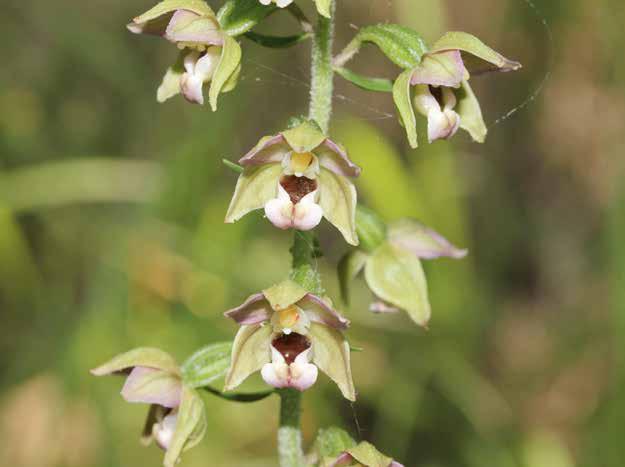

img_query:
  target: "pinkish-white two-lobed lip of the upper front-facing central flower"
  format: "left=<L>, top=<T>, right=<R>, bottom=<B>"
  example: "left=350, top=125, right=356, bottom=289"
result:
left=265, top=185, right=323, bottom=230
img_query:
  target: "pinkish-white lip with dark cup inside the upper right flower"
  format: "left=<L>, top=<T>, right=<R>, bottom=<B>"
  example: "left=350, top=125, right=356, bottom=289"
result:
left=414, top=85, right=460, bottom=143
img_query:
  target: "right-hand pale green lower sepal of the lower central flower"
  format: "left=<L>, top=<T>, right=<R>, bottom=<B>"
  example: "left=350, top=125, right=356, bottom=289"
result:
left=309, top=322, right=356, bottom=401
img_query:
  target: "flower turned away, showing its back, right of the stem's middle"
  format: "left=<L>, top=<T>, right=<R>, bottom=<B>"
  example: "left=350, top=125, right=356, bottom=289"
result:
left=339, top=206, right=467, bottom=326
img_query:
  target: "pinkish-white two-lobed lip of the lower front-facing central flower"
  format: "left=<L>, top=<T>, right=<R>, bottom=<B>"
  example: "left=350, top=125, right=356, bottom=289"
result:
left=261, top=345, right=319, bottom=391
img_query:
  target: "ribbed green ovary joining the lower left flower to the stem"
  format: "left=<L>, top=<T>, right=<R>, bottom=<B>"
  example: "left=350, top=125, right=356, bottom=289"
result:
left=181, top=342, right=232, bottom=388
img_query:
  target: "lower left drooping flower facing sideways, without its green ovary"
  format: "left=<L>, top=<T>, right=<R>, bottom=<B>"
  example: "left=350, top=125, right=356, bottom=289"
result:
left=91, top=348, right=206, bottom=467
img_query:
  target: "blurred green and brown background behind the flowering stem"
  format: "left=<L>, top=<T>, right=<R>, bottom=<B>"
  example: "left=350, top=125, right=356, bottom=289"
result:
left=0, top=0, right=625, bottom=467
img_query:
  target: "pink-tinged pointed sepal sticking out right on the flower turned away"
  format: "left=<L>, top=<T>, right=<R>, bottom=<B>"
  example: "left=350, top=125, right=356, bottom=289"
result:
left=389, top=219, right=468, bottom=259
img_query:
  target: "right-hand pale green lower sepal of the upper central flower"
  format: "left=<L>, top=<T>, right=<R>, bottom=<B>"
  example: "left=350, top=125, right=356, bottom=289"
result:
left=319, top=168, right=358, bottom=246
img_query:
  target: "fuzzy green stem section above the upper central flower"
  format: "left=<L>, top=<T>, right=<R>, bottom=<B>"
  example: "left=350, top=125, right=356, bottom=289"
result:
left=308, top=1, right=335, bottom=133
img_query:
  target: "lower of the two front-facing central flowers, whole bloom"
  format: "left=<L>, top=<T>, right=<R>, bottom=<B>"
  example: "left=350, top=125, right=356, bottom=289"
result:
left=225, top=280, right=356, bottom=401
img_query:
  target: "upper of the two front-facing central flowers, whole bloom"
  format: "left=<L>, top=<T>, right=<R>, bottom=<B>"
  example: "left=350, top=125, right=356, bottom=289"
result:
left=226, top=121, right=360, bottom=245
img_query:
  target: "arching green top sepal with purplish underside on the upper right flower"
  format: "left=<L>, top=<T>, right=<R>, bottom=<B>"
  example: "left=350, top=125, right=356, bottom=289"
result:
left=430, top=31, right=521, bottom=73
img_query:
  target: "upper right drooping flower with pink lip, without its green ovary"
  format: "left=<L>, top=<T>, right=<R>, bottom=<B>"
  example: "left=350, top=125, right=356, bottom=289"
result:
left=393, top=32, right=521, bottom=147
